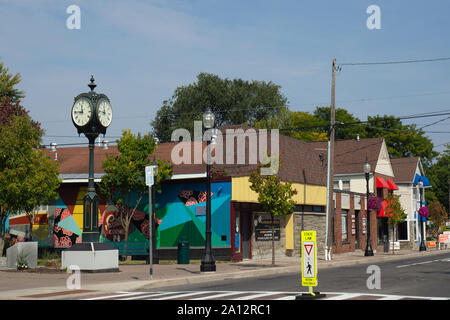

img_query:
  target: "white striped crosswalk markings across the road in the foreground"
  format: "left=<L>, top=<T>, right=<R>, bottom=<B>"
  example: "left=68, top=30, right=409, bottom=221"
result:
left=80, top=291, right=450, bottom=300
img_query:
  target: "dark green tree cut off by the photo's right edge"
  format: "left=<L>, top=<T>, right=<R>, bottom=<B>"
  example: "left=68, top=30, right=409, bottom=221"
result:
left=425, top=144, right=450, bottom=212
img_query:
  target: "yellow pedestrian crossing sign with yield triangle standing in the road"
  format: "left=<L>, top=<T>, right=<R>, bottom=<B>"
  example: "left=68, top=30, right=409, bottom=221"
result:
left=302, top=231, right=317, bottom=287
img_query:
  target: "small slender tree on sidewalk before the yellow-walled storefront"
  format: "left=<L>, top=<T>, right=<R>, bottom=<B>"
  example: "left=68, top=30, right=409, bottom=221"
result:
left=249, top=158, right=297, bottom=266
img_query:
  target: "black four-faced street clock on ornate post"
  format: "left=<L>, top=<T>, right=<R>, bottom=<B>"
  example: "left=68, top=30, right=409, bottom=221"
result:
left=72, top=75, right=112, bottom=242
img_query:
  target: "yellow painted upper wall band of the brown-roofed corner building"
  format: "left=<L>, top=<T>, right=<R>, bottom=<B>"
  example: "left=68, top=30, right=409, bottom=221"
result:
left=231, top=177, right=327, bottom=206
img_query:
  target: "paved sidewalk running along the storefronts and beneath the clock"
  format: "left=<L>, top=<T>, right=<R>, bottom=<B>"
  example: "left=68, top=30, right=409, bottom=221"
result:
left=0, top=250, right=450, bottom=299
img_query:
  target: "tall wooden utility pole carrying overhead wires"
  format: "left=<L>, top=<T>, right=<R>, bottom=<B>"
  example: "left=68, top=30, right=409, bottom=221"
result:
left=325, top=59, right=336, bottom=260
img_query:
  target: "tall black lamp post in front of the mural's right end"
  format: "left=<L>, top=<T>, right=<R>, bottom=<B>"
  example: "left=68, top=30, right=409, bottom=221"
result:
left=200, top=107, right=216, bottom=272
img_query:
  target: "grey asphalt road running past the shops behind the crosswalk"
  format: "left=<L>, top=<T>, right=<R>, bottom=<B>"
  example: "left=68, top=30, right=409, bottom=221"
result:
left=145, top=252, right=450, bottom=298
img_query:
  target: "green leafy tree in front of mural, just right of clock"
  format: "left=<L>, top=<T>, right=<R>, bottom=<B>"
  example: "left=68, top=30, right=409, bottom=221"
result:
left=99, top=130, right=172, bottom=241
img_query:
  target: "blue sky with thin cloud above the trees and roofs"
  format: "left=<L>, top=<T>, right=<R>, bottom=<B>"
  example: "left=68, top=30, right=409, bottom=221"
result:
left=0, top=0, right=450, bottom=151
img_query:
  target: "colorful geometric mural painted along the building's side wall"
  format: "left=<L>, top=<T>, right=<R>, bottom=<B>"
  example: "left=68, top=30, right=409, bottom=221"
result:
left=5, top=181, right=231, bottom=252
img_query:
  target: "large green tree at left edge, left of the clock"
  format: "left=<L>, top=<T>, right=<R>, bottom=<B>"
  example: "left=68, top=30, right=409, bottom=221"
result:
left=0, top=116, right=60, bottom=252
